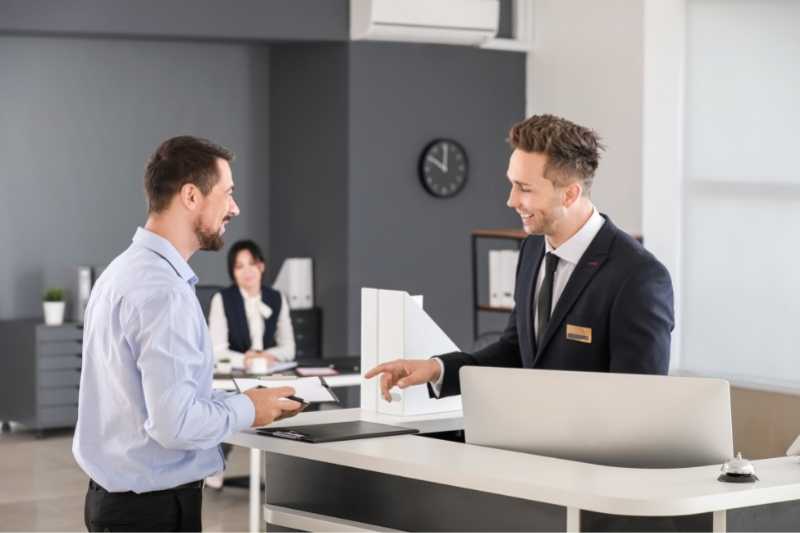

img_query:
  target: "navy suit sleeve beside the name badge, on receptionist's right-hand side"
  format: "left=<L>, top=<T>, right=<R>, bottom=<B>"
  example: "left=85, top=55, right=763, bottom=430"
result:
left=609, top=261, right=675, bottom=375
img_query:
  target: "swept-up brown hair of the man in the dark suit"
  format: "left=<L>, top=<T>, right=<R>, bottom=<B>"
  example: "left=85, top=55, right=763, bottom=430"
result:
left=508, top=115, right=605, bottom=195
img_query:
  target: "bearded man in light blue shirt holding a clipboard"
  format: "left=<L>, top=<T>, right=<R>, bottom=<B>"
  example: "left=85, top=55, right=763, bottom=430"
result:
left=73, top=137, right=301, bottom=531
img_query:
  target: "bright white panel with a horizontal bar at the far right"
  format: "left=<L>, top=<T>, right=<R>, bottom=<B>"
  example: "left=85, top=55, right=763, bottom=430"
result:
left=676, top=0, right=800, bottom=389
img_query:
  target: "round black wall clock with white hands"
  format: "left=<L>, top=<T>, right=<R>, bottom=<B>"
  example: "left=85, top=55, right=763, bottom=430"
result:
left=419, top=139, right=469, bottom=198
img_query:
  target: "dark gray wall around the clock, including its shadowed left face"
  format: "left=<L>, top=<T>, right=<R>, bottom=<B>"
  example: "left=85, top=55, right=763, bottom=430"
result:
left=270, top=42, right=525, bottom=356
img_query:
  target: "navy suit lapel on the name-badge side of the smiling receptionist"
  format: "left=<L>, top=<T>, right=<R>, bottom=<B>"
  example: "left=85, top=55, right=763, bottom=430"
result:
left=533, top=217, right=618, bottom=366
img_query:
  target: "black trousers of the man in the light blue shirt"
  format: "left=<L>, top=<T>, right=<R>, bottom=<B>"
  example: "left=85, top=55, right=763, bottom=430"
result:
left=84, top=481, right=203, bottom=531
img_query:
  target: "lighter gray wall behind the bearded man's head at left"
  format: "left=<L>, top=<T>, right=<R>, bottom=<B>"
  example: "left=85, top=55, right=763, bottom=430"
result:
left=0, top=36, right=269, bottom=318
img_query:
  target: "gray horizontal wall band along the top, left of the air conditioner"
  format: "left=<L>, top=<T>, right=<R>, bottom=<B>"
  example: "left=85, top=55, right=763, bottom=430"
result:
left=0, top=0, right=350, bottom=41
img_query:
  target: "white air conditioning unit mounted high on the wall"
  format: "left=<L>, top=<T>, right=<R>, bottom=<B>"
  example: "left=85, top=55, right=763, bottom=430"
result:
left=350, top=0, right=500, bottom=46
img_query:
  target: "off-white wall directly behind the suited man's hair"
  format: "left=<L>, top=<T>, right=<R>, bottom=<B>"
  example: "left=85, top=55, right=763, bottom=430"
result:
left=527, top=0, right=647, bottom=235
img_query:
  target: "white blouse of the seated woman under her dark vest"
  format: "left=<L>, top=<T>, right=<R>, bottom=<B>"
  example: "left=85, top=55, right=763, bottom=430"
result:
left=208, top=289, right=295, bottom=369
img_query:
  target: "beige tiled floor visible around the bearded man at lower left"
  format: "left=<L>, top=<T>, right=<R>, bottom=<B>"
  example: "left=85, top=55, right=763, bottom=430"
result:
left=0, top=428, right=249, bottom=531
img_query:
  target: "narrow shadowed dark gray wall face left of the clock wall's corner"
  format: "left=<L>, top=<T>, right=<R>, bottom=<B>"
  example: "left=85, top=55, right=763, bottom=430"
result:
left=269, top=44, right=350, bottom=356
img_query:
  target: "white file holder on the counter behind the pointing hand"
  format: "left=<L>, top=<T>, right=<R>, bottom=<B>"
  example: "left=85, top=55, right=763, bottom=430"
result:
left=361, top=288, right=461, bottom=416
